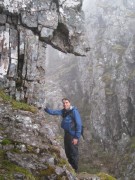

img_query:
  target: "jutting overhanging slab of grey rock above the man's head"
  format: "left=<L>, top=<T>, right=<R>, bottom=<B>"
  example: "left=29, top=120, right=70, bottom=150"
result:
left=0, top=0, right=88, bottom=55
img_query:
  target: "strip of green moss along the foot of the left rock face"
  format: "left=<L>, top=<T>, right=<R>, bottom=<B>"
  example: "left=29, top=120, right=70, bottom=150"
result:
left=0, top=90, right=37, bottom=113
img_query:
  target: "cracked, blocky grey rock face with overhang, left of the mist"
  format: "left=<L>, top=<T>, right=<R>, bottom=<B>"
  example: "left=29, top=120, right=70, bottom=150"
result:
left=0, top=0, right=87, bottom=106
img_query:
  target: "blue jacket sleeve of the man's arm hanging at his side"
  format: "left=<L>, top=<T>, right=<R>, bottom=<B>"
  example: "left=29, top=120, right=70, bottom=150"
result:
left=73, top=109, right=82, bottom=139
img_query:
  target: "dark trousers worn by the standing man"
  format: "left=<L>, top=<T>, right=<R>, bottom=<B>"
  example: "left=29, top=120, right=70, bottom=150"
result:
left=64, top=132, right=79, bottom=171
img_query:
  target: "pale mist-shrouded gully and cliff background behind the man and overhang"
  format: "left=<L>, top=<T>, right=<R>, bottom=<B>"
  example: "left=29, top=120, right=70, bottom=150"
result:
left=46, top=0, right=135, bottom=180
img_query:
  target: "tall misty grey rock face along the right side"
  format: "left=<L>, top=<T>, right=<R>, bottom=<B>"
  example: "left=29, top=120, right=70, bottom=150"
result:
left=80, top=0, right=135, bottom=177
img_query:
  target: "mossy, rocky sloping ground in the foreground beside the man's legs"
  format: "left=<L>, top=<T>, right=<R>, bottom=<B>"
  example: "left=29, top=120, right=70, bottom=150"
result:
left=0, top=91, right=116, bottom=180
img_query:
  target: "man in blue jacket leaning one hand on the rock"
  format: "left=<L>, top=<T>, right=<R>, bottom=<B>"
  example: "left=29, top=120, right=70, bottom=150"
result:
left=45, top=98, right=82, bottom=172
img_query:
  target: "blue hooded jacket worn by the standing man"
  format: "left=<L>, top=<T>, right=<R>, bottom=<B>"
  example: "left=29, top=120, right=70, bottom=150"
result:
left=44, top=107, right=82, bottom=139
